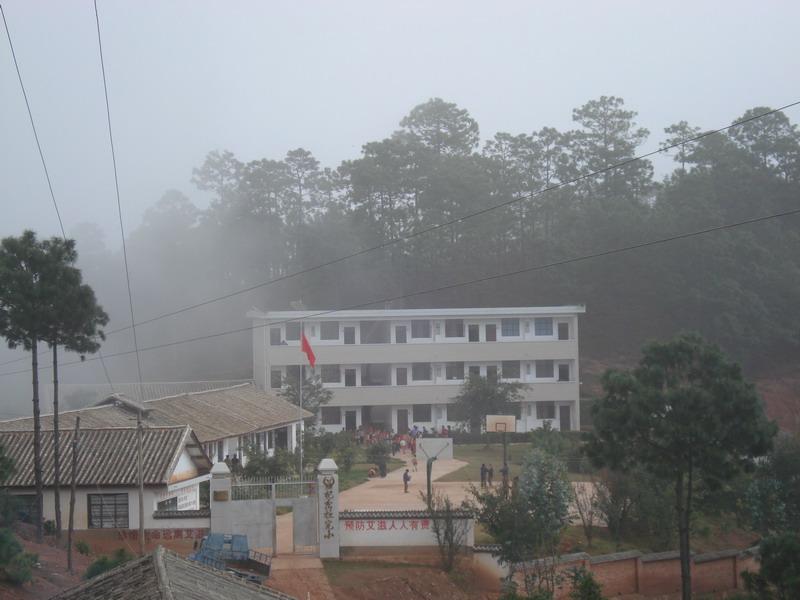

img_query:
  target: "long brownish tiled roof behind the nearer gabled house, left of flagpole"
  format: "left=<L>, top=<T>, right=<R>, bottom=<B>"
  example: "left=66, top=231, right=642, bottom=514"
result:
left=0, top=383, right=313, bottom=443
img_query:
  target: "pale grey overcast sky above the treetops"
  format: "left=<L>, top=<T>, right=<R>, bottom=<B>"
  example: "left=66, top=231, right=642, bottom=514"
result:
left=0, top=0, right=800, bottom=245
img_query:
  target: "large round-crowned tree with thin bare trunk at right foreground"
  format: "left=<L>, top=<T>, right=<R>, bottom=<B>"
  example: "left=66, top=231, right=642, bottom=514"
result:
left=586, top=334, right=775, bottom=600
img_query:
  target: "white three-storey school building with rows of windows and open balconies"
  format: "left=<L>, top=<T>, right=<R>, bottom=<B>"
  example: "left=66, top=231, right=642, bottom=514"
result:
left=248, top=306, right=585, bottom=432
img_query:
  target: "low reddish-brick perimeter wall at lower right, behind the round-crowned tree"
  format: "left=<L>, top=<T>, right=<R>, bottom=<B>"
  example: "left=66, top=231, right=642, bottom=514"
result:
left=473, top=547, right=758, bottom=598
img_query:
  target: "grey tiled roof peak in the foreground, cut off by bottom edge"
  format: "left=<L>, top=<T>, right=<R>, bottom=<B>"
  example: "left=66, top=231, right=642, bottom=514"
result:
left=50, top=547, right=295, bottom=600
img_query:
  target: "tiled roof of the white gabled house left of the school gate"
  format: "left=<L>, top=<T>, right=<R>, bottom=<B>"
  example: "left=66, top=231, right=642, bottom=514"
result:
left=0, top=426, right=211, bottom=487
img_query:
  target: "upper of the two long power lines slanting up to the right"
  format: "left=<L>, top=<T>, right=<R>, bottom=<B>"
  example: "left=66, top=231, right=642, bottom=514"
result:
left=75, top=100, right=800, bottom=335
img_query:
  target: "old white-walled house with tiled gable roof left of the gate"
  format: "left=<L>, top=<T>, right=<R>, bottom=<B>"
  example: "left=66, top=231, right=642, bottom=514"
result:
left=0, top=425, right=212, bottom=530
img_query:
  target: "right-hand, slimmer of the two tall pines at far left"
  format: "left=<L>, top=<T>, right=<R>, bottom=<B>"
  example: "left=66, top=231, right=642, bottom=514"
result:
left=42, top=238, right=108, bottom=538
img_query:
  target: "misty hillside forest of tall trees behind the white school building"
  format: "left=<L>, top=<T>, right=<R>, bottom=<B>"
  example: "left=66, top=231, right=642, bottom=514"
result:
left=70, top=96, right=800, bottom=381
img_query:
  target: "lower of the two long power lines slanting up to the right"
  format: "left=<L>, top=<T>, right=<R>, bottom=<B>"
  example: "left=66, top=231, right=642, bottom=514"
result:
left=0, top=208, right=800, bottom=377
